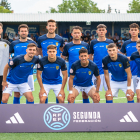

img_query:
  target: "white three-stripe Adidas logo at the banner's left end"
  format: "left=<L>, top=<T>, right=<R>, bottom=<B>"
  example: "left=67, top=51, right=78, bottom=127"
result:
left=6, top=112, right=24, bottom=124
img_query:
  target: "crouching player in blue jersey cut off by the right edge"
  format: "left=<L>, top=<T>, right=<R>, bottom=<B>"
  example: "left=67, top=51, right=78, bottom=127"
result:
left=130, top=40, right=140, bottom=103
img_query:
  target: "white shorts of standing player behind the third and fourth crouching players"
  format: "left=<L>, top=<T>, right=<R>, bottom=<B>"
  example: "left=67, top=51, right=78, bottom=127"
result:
left=92, top=73, right=111, bottom=91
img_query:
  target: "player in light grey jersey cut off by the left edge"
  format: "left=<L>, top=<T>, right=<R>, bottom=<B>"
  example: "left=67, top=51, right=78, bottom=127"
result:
left=0, top=23, right=10, bottom=103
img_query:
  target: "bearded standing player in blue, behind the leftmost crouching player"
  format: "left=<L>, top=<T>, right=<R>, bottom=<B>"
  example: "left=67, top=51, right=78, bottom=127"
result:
left=9, top=24, right=36, bottom=104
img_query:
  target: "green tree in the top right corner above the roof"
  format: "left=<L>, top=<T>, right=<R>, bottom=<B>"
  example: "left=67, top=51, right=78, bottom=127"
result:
left=127, top=0, right=140, bottom=13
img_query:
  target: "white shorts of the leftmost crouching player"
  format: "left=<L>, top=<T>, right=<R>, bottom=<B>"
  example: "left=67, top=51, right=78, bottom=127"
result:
left=3, top=82, right=32, bottom=96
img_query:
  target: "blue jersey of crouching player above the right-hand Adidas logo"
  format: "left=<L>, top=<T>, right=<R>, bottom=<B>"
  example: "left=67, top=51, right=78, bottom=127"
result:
left=102, top=54, right=130, bottom=82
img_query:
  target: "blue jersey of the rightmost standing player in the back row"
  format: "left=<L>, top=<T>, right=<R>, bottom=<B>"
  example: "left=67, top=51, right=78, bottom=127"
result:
left=121, top=39, right=138, bottom=75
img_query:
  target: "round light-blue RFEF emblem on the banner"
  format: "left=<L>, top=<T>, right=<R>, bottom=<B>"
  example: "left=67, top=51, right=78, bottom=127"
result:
left=43, top=105, right=71, bottom=130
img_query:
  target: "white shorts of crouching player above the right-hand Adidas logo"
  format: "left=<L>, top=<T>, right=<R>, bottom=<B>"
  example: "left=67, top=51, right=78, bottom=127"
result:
left=110, top=79, right=134, bottom=97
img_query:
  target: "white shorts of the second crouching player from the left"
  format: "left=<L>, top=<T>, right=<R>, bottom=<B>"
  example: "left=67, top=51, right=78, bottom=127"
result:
left=43, top=84, right=62, bottom=97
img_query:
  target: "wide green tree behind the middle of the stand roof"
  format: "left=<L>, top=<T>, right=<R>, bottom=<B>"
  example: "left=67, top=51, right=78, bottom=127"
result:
left=46, top=0, right=105, bottom=13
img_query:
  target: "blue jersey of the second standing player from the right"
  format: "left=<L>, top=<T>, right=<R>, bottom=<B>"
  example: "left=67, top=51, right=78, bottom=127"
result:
left=90, top=39, right=113, bottom=74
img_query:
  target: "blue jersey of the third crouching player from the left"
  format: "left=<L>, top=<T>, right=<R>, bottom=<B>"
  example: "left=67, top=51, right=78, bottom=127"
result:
left=70, top=60, right=99, bottom=87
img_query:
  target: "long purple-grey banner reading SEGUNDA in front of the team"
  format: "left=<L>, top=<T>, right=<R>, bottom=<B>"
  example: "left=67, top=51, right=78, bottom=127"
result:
left=0, top=103, right=140, bottom=132
